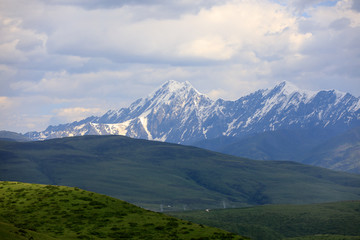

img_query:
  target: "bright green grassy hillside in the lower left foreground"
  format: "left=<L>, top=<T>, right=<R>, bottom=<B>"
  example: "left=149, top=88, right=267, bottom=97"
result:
left=0, top=182, right=244, bottom=240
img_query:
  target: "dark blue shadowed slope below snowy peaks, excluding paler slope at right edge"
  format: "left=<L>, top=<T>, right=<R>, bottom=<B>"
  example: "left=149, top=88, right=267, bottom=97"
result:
left=194, top=129, right=337, bottom=161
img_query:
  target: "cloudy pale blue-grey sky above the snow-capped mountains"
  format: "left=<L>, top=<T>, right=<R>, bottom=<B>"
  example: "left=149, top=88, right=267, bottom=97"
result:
left=0, top=0, right=360, bottom=132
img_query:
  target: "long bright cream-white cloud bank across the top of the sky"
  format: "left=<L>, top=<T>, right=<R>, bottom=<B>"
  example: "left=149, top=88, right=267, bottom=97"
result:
left=42, top=1, right=302, bottom=64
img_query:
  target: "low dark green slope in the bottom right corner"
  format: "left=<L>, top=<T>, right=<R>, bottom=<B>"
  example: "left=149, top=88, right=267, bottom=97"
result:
left=170, top=201, right=360, bottom=240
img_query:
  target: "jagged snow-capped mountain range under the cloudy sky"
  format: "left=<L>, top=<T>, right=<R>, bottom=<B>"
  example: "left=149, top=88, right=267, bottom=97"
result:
left=28, top=80, right=360, bottom=143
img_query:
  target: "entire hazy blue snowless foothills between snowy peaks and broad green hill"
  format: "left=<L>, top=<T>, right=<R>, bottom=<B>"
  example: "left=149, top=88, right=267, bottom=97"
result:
left=194, top=127, right=360, bottom=173
